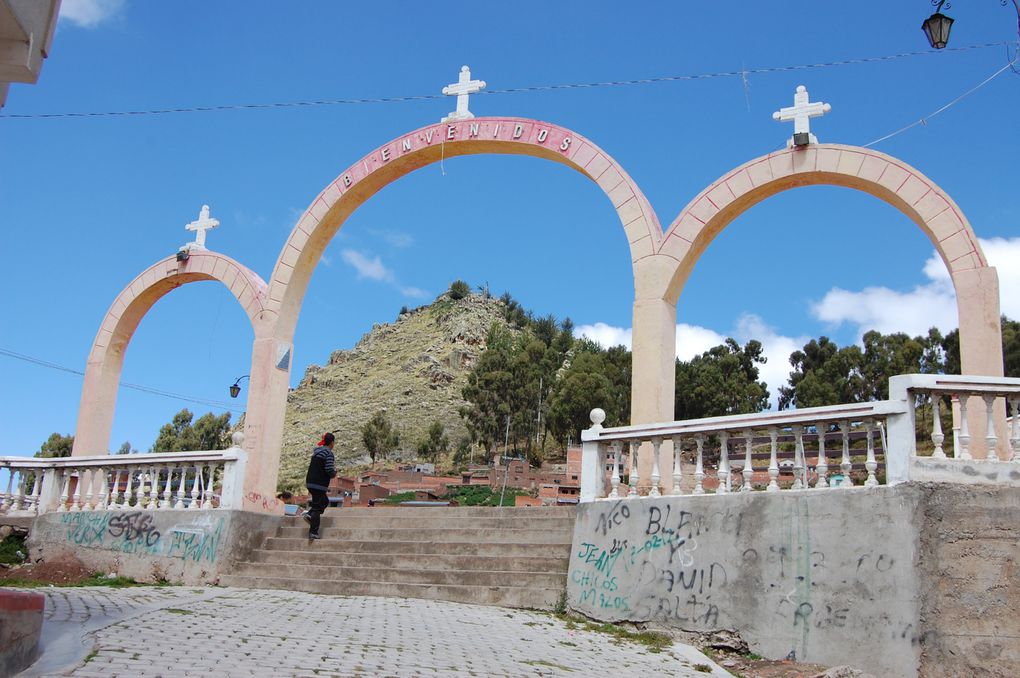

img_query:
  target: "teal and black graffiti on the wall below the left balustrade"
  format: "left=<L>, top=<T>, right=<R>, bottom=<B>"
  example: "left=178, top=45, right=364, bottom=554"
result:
left=60, top=511, right=223, bottom=563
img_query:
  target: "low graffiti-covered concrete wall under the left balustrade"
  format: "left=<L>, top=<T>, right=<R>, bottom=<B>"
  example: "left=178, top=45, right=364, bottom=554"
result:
left=28, top=510, right=282, bottom=584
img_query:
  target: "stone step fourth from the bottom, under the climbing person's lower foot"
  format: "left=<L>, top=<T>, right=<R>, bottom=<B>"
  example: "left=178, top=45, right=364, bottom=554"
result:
left=262, top=530, right=570, bottom=558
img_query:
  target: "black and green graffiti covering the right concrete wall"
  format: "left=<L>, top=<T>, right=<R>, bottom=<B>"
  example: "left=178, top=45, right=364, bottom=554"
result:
left=567, top=500, right=909, bottom=657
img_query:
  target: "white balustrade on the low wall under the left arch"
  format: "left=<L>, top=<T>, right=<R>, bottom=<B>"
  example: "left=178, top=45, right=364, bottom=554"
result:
left=0, top=433, right=244, bottom=515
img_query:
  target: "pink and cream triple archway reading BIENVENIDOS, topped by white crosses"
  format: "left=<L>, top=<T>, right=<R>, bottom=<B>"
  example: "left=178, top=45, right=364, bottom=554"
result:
left=73, top=75, right=1004, bottom=511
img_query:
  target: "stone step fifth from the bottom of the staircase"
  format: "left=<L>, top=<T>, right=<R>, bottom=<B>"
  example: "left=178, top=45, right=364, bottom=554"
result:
left=276, top=521, right=573, bottom=543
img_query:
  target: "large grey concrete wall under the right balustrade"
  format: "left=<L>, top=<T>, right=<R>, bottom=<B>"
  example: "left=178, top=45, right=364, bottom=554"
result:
left=567, top=484, right=1020, bottom=676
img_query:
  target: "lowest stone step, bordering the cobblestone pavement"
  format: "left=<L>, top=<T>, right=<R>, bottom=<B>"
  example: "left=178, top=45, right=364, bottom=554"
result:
left=219, top=575, right=564, bottom=610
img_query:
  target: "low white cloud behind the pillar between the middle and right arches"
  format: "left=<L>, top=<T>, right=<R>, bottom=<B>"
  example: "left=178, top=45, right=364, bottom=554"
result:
left=574, top=313, right=810, bottom=408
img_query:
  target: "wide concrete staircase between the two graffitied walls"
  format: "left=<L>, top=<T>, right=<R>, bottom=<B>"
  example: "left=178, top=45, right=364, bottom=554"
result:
left=219, top=507, right=576, bottom=610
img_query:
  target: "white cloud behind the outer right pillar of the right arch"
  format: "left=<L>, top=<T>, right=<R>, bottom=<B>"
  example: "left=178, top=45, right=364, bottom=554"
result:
left=811, top=238, right=1020, bottom=336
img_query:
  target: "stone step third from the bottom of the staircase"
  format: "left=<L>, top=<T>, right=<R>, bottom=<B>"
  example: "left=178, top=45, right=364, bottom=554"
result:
left=251, top=539, right=569, bottom=573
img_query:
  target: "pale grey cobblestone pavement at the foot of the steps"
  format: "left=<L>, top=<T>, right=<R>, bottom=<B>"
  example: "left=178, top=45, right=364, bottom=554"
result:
left=21, top=586, right=729, bottom=678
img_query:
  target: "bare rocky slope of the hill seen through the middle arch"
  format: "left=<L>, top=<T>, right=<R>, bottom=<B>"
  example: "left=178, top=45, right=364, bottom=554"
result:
left=279, top=294, right=504, bottom=488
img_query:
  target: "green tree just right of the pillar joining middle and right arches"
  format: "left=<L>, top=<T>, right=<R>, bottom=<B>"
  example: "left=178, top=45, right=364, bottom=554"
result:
left=674, top=338, right=768, bottom=419
